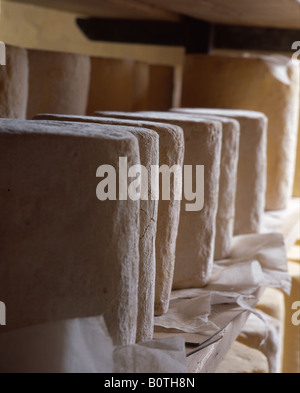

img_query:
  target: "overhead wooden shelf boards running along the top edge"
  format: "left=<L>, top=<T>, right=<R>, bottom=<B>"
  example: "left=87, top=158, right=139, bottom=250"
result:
left=12, top=0, right=300, bottom=29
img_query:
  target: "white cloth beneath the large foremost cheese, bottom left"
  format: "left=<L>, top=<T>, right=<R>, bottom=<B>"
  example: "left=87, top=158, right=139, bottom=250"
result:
left=0, top=317, right=187, bottom=374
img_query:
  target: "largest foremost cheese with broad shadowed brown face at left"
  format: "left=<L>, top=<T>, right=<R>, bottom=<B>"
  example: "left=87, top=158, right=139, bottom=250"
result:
left=0, top=120, right=140, bottom=345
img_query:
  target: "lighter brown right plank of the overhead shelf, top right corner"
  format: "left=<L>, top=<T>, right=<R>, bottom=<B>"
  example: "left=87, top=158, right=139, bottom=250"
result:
left=138, top=0, right=300, bottom=29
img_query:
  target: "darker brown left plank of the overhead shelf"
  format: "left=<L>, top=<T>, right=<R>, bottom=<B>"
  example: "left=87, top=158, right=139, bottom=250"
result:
left=11, top=0, right=179, bottom=21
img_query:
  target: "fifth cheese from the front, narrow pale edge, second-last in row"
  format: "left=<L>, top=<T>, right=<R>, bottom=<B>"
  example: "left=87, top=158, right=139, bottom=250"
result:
left=174, top=109, right=240, bottom=260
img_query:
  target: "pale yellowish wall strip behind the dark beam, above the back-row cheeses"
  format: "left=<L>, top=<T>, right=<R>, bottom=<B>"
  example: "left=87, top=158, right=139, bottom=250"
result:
left=0, top=0, right=185, bottom=66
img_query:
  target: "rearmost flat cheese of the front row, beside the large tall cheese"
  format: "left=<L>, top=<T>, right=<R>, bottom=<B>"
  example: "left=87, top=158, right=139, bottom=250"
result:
left=178, top=109, right=268, bottom=235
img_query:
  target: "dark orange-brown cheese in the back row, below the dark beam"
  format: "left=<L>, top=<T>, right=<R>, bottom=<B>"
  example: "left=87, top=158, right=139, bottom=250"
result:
left=86, top=58, right=149, bottom=115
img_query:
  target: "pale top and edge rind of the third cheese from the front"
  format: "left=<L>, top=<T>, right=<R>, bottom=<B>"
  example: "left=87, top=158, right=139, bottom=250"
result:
left=36, top=115, right=184, bottom=318
